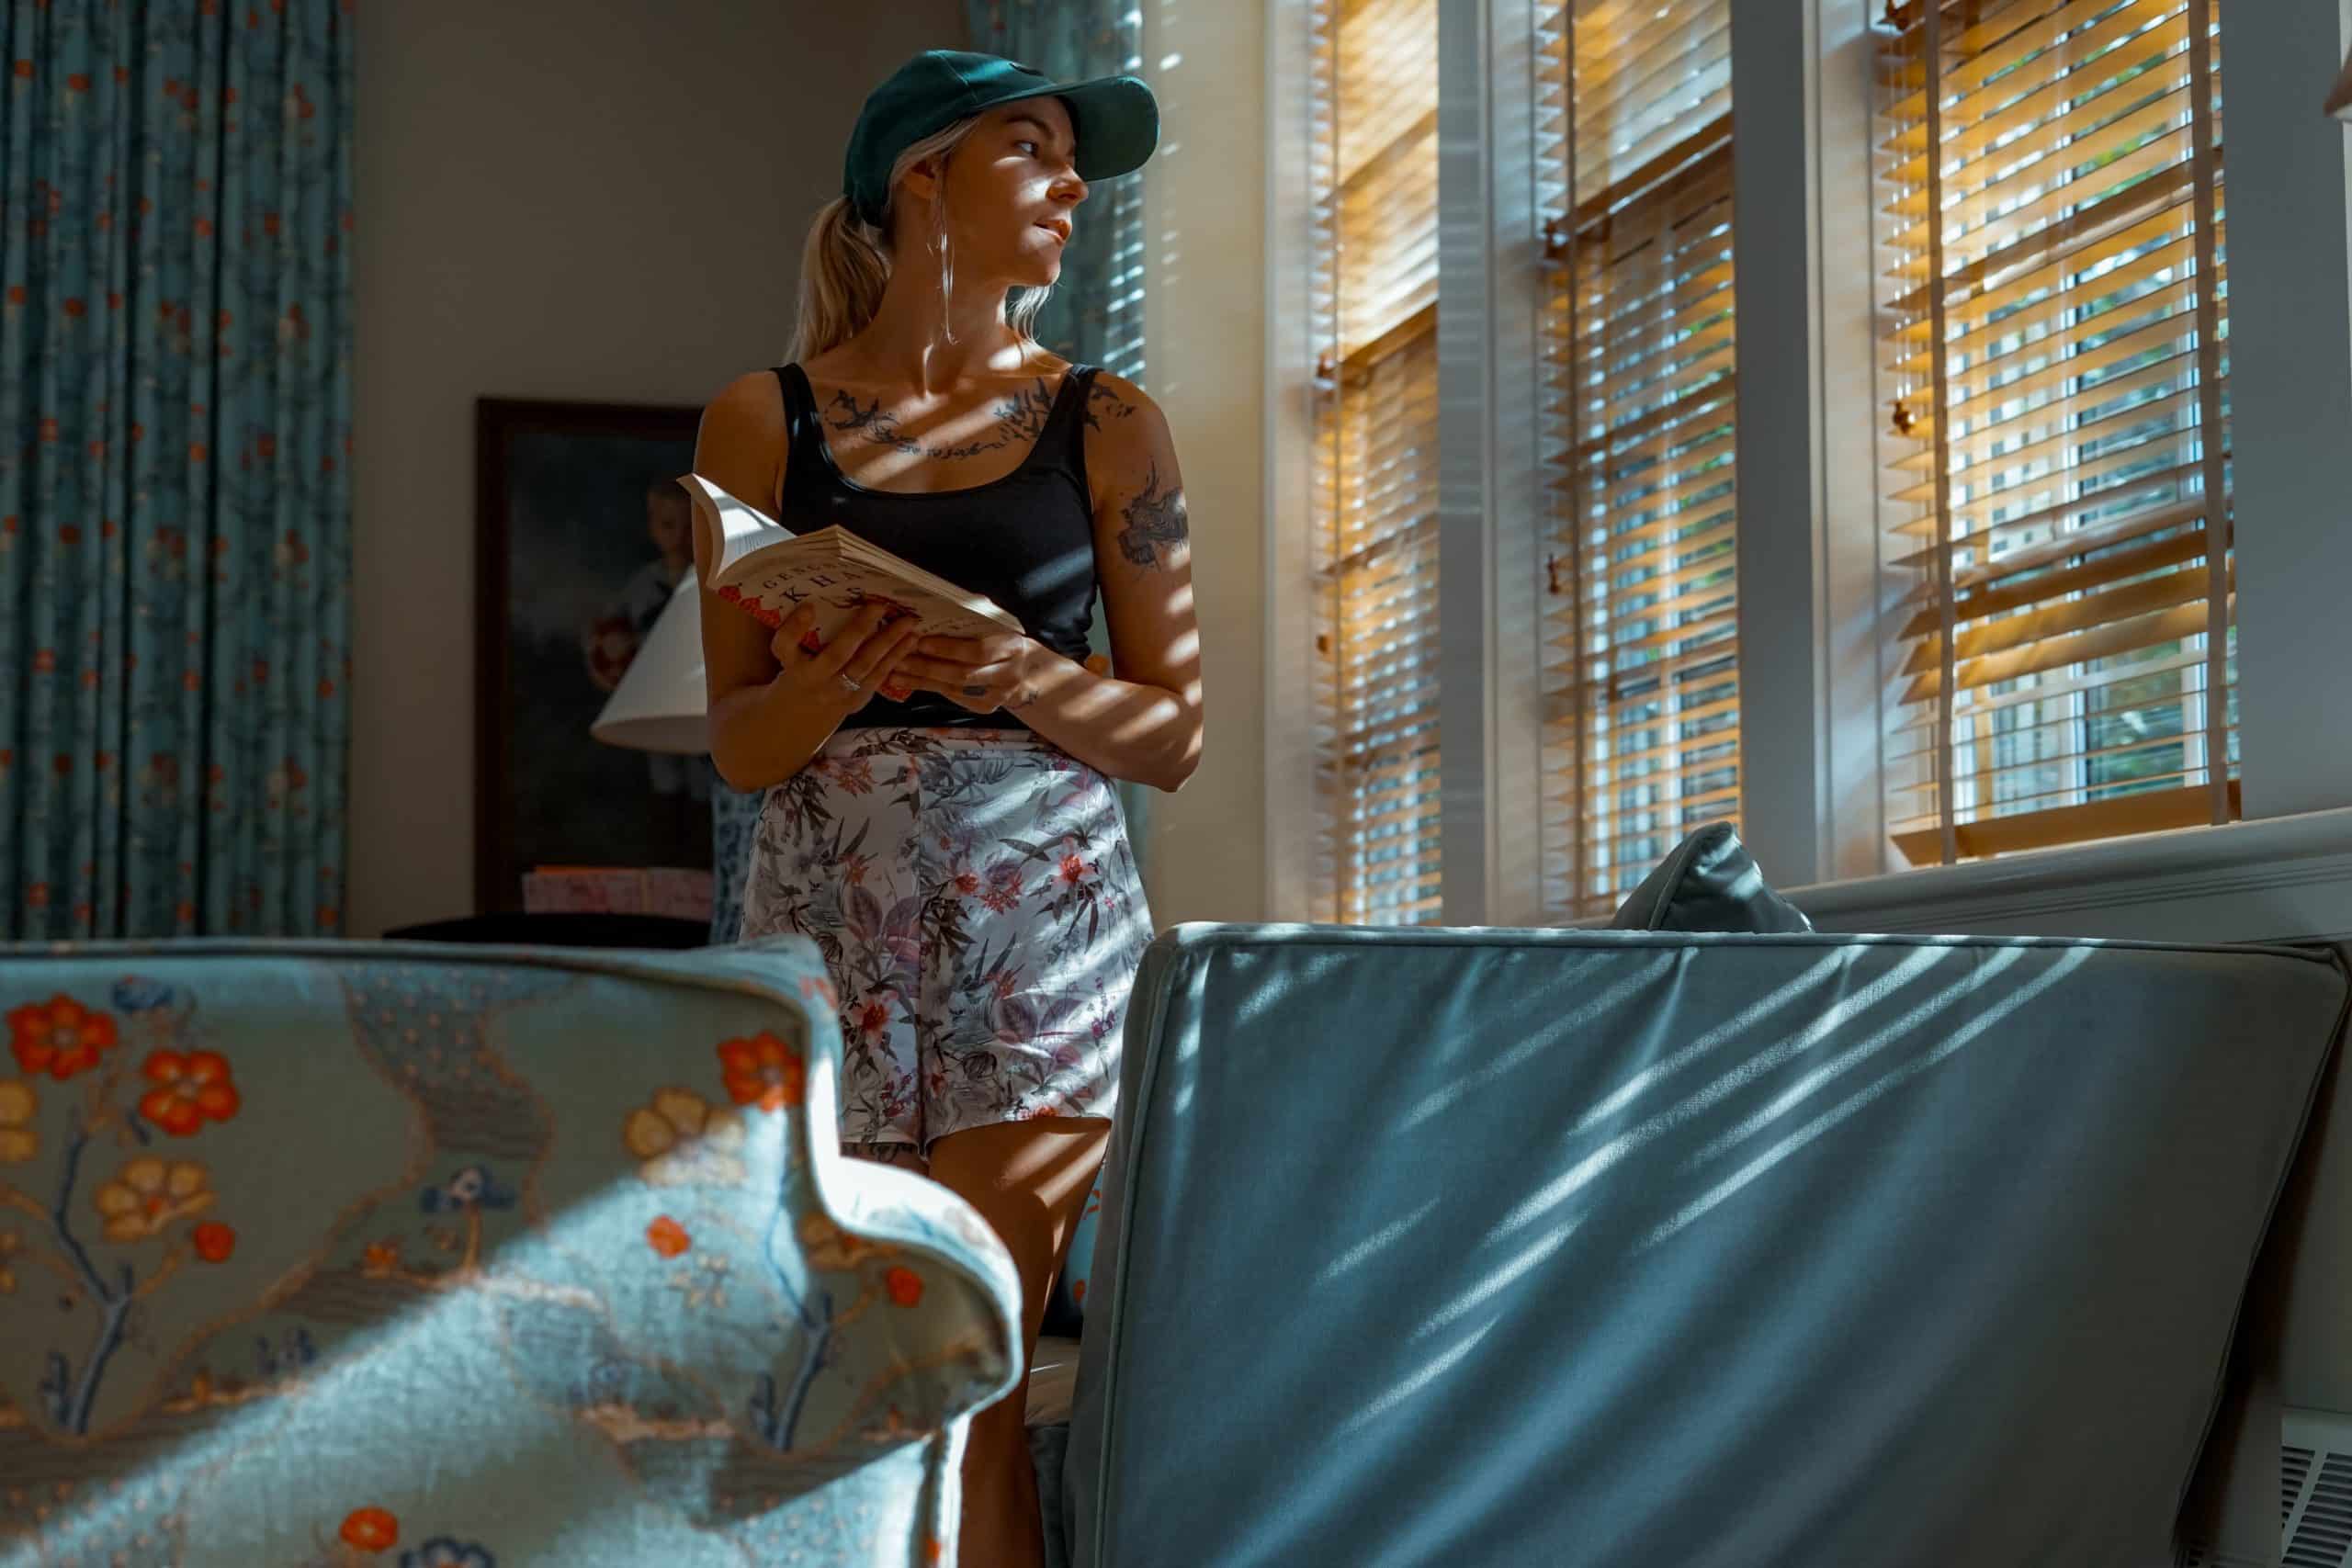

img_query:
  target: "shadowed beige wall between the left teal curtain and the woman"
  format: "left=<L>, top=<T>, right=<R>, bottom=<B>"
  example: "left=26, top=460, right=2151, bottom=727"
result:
left=350, top=0, right=965, bottom=936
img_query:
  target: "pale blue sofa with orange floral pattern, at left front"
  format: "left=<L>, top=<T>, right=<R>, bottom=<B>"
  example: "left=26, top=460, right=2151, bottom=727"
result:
left=0, top=938, right=1018, bottom=1568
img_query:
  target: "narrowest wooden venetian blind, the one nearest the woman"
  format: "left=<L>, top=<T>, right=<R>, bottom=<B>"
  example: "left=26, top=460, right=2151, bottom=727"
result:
left=1312, top=0, right=1440, bottom=924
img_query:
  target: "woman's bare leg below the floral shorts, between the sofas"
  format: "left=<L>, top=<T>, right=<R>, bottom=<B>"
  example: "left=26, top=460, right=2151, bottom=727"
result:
left=932, top=1117, right=1110, bottom=1568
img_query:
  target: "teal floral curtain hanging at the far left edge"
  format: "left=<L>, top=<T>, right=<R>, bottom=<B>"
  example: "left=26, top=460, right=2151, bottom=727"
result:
left=0, top=0, right=353, bottom=938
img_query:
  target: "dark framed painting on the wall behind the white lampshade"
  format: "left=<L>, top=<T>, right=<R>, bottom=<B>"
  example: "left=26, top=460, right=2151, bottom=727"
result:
left=472, top=398, right=710, bottom=915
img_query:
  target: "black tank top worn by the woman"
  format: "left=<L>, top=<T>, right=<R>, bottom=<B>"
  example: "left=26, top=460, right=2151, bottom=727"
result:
left=776, top=365, right=1096, bottom=728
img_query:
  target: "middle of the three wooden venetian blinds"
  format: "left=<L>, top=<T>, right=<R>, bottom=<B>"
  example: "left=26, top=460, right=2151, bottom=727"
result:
left=1536, top=0, right=1740, bottom=917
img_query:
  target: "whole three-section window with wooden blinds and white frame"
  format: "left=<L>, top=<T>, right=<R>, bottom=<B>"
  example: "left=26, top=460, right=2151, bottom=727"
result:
left=1268, top=0, right=2324, bottom=924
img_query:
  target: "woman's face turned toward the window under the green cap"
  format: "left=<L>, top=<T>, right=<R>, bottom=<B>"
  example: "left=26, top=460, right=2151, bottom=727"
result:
left=926, top=98, right=1087, bottom=289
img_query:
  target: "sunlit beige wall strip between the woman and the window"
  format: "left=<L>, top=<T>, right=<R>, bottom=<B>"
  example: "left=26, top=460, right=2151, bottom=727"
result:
left=1143, top=0, right=1265, bottom=926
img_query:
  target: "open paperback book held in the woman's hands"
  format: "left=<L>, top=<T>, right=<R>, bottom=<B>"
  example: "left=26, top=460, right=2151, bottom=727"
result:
left=677, top=472, right=1023, bottom=653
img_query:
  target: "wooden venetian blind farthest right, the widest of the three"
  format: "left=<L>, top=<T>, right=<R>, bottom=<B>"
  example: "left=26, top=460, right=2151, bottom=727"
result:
left=1877, top=0, right=2237, bottom=865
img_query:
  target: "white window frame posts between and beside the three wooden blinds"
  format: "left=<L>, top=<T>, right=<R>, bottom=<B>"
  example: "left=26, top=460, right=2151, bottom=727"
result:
left=1265, top=0, right=2352, bottom=931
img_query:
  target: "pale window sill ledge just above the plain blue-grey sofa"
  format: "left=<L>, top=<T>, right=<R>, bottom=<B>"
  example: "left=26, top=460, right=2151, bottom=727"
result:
left=1782, top=808, right=2352, bottom=942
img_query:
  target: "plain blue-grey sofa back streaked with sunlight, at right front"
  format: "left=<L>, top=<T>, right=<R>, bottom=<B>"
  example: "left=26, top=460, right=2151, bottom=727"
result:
left=1053, top=926, right=2347, bottom=1568
